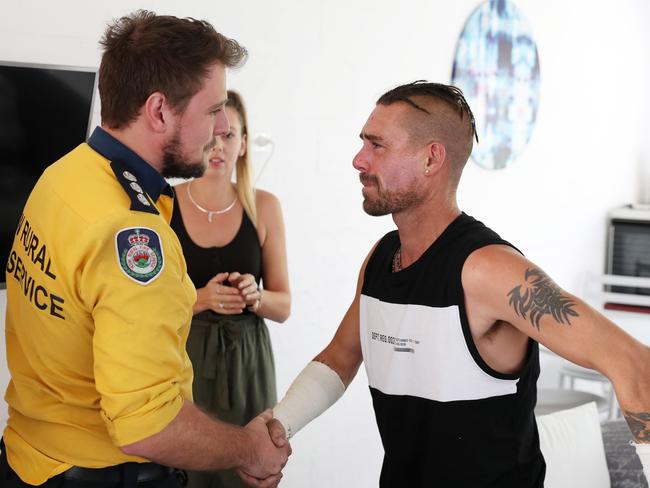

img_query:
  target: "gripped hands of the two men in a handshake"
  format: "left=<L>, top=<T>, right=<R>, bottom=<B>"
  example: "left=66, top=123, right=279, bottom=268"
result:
left=237, top=410, right=291, bottom=488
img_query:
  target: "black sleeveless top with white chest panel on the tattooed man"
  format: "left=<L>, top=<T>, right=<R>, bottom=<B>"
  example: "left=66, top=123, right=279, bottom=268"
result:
left=360, top=214, right=545, bottom=488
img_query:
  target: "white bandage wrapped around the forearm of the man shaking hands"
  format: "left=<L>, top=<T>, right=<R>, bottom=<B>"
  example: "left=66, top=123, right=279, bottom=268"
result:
left=273, top=361, right=345, bottom=439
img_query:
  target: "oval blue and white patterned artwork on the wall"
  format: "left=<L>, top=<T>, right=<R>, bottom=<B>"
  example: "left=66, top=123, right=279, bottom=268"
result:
left=451, top=0, right=540, bottom=169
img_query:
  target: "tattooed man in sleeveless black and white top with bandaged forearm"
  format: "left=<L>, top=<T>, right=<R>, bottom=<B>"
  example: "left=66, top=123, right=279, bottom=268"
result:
left=264, top=82, right=650, bottom=488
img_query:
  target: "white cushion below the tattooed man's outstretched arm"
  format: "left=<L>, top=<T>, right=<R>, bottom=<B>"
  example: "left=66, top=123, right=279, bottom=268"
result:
left=537, top=402, right=610, bottom=488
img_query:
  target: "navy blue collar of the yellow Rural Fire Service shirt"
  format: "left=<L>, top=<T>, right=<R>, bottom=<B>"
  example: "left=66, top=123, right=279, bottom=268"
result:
left=88, top=127, right=174, bottom=202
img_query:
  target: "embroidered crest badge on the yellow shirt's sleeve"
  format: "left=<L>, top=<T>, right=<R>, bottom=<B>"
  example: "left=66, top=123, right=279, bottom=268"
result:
left=115, top=227, right=164, bottom=285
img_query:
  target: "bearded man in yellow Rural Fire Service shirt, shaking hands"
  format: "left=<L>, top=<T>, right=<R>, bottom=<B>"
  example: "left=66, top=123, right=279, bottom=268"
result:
left=0, top=11, right=289, bottom=487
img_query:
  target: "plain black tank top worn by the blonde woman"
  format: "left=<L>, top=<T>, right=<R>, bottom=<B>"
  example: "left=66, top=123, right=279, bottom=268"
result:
left=170, top=198, right=262, bottom=288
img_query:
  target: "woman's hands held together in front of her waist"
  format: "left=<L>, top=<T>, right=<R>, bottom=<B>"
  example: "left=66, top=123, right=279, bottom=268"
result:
left=195, top=271, right=261, bottom=315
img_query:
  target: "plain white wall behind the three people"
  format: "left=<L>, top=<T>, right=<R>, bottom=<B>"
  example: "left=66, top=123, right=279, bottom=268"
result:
left=0, top=0, right=650, bottom=488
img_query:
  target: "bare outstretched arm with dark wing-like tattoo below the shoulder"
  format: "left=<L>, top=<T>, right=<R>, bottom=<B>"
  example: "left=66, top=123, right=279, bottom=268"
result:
left=462, top=246, right=650, bottom=477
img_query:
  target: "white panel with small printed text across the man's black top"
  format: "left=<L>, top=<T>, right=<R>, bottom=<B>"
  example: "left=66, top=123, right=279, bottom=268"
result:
left=360, top=295, right=519, bottom=402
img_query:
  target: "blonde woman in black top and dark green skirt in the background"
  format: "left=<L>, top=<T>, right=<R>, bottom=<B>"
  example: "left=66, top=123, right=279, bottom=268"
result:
left=171, top=91, right=291, bottom=488
